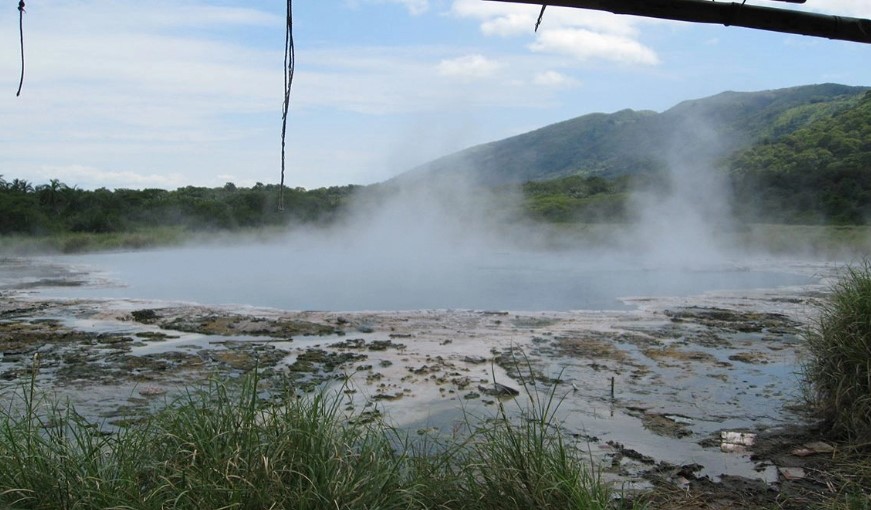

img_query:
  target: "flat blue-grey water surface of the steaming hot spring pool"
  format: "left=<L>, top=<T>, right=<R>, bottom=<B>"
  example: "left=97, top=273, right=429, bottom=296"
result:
left=30, top=244, right=813, bottom=311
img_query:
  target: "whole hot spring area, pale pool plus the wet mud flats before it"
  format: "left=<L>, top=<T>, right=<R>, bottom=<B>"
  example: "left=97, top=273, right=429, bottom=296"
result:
left=0, top=252, right=835, bottom=494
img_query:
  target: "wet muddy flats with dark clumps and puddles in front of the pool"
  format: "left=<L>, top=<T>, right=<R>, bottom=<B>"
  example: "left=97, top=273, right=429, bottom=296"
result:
left=0, top=259, right=852, bottom=508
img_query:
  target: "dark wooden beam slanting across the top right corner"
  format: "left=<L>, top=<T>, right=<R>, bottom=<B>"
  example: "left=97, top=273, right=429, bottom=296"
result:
left=488, top=0, right=871, bottom=44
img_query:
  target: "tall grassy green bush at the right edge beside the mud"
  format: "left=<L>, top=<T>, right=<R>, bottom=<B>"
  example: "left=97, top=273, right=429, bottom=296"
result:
left=803, top=260, right=871, bottom=441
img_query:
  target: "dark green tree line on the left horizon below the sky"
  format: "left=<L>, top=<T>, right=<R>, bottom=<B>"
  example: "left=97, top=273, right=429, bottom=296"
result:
left=0, top=175, right=358, bottom=235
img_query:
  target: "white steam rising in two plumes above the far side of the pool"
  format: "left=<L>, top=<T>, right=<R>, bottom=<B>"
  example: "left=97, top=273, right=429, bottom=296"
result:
left=322, top=111, right=736, bottom=271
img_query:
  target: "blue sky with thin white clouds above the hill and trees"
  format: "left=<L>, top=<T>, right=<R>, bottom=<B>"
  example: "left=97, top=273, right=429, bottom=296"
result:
left=0, top=0, right=871, bottom=189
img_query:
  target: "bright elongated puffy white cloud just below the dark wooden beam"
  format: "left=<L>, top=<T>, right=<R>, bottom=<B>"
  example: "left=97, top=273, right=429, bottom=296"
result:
left=530, top=29, right=659, bottom=65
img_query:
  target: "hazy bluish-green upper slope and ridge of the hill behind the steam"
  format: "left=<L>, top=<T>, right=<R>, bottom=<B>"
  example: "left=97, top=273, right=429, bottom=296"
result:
left=398, top=84, right=868, bottom=185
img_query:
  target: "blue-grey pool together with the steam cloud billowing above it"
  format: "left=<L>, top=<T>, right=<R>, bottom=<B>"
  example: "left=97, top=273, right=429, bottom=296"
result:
left=42, top=157, right=807, bottom=311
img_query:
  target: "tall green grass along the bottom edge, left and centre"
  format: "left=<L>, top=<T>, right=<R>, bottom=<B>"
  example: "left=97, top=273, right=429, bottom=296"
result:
left=0, top=373, right=631, bottom=510
